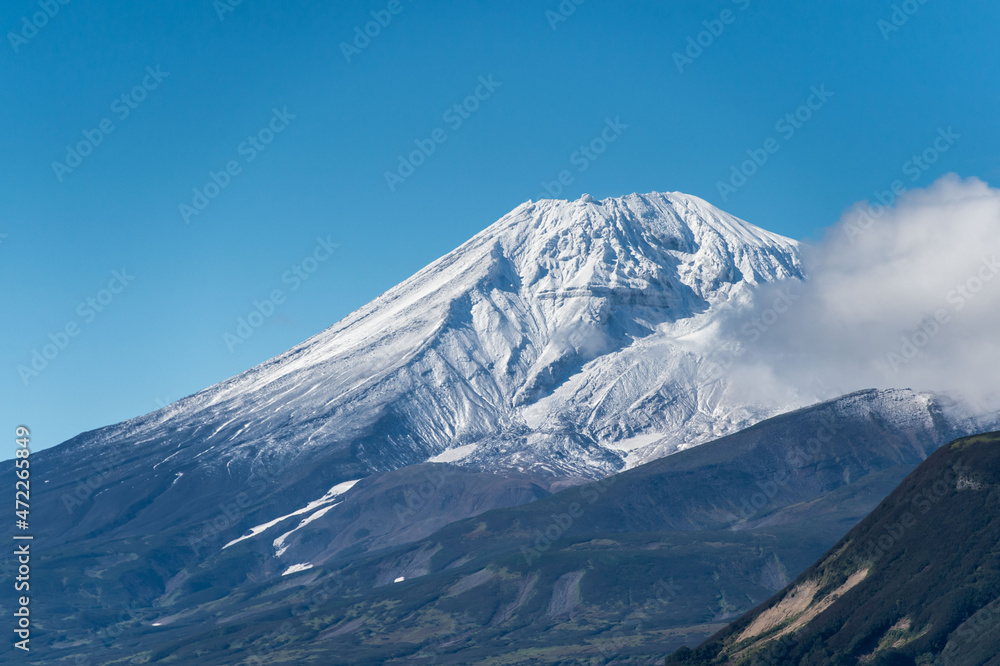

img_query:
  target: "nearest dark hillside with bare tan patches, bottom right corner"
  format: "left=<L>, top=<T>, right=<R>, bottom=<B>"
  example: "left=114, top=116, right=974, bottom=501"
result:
left=667, top=433, right=1000, bottom=666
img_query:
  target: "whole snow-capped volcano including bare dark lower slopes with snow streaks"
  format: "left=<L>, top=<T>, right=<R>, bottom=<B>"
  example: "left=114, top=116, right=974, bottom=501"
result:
left=0, top=193, right=820, bottom=660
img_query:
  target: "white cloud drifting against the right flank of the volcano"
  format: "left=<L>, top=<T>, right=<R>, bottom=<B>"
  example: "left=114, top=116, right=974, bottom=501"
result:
left=725, top=175, right=1000, bottom=410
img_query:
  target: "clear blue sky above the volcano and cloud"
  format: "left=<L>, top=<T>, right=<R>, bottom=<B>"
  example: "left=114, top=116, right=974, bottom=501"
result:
left=0, top=0, right=1000, bottom=457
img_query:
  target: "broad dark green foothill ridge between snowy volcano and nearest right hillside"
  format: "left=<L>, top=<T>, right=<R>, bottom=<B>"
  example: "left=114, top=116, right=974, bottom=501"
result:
left=5, top=391, right=976, bottom=664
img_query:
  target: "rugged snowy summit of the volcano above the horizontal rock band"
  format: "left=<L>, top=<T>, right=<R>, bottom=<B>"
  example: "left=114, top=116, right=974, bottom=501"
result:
left=472, top=192, right=801, bottom=309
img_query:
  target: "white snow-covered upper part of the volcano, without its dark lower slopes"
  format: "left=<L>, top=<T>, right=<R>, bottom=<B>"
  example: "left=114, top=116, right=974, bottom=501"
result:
left=72, top=193, right=801, bottom=477
